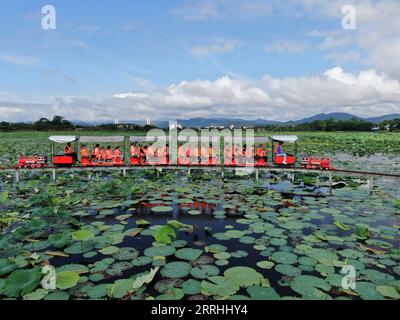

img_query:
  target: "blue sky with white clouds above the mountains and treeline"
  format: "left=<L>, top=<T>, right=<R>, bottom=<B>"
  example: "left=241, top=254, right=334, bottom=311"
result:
left=0, top=0, right=400, bottom=121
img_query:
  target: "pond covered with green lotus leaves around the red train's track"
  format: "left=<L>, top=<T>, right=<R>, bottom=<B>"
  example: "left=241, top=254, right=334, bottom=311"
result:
left=0, top=132, right=400, bottom=300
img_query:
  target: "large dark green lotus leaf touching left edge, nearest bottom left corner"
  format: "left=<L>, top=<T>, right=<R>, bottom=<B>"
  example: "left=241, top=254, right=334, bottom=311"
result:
left=1, top=268, right=42, bottom=297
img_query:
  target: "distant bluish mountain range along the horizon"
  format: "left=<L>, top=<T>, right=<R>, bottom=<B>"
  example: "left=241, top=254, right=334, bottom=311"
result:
left=73, top=112, right=400, bottom=128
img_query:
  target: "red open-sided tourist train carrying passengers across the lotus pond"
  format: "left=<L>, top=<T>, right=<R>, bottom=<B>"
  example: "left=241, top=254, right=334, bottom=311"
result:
left=17, top=135, right=332, bottom=170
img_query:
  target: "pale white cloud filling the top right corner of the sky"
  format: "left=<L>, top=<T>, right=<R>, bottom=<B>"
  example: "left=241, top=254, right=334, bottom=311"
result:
left=291, top=0, right=400, bottom=79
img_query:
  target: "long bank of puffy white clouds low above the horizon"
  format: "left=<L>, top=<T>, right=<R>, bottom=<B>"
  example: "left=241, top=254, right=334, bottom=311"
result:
left=0, top=67, right=400, bottom=121
